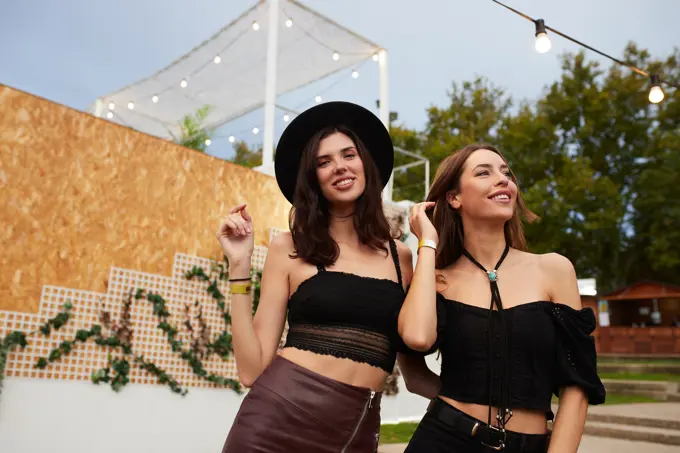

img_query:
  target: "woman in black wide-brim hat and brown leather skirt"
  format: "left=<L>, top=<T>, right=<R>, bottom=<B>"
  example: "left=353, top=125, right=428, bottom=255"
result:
left=217, top=102, right=439, bottom=453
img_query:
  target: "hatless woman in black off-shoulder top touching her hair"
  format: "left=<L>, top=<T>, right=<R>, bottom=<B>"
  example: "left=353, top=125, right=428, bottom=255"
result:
left=399, top=145, right=605, bottom=453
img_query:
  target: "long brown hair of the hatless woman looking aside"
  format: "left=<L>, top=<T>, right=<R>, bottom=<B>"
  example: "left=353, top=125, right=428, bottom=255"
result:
left=427, top=144, right=538, bottom=269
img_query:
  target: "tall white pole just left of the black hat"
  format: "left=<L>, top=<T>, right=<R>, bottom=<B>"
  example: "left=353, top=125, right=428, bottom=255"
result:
left=262, top=0, right=279, bottom=172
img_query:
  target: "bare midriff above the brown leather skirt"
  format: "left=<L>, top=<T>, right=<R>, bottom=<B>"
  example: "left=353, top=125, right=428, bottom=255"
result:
left=279, top=348, right=389, bottom=392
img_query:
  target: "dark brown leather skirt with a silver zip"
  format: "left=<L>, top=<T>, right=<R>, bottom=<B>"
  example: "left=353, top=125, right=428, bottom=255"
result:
left=222, top=355, right=381, bottom=453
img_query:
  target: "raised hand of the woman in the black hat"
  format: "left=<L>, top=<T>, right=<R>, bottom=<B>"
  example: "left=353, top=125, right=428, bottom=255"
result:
left=215, top=204, right=254, bottom=277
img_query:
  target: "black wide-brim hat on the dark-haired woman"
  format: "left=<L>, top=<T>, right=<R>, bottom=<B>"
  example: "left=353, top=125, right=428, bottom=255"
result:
left=274, top=101, right=394, bottom=204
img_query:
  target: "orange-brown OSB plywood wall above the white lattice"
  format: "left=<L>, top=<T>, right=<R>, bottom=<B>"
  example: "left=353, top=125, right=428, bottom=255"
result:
left=0, top=85, right=290, bottom=313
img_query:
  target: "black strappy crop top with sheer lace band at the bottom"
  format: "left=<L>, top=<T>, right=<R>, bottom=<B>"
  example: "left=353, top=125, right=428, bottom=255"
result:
left=284, top=241, right=406, bottom=373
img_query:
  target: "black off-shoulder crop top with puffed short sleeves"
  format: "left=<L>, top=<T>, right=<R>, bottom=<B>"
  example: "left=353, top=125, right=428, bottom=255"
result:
left=432, top=294, right=605, bottom=419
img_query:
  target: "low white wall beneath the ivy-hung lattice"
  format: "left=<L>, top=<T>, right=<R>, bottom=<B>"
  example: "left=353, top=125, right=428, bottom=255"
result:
left=0, top=355, right=439, bottom=453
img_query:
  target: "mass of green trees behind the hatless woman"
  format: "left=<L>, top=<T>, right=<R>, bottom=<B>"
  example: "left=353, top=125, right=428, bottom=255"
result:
left=391, top=44, right=680, bottom=292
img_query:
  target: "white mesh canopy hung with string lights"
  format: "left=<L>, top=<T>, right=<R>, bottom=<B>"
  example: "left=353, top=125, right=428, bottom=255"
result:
left=95, top=0, right=386, bottom=139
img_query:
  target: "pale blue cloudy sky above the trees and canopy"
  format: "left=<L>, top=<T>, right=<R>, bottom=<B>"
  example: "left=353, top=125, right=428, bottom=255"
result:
left=0, top=0, right=680, bottom=161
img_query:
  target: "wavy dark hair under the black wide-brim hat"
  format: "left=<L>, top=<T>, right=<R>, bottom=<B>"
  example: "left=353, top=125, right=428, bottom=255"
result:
left=288, top=125, right=392, bottom=267
